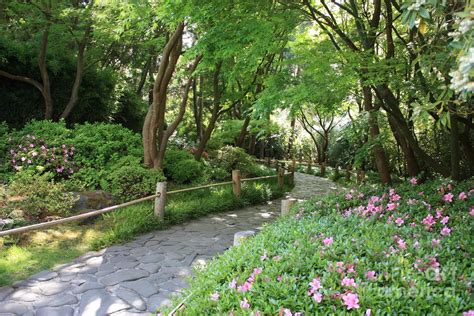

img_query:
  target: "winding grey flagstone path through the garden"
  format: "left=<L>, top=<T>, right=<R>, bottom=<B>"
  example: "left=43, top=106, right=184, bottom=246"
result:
left=0, top=173, right=335, bottom=316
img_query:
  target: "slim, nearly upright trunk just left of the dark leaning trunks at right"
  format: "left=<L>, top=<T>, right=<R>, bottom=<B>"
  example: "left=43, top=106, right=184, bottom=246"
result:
left=362, top=86, right=391, bottom=183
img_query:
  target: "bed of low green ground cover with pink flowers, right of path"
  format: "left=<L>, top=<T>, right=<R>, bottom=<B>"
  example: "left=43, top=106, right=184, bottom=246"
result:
left=170, top=179, right=474, bottom=315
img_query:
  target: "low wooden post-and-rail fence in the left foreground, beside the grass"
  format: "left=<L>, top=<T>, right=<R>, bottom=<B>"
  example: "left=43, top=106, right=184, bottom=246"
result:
left=0, top=168, right=294, bottom=237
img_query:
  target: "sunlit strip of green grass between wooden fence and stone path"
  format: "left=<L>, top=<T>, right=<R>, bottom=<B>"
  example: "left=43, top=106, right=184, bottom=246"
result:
left=0, top=179, right=288, bottom=286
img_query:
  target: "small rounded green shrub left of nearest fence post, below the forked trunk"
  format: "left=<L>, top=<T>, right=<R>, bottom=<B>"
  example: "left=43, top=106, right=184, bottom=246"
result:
left=107, top=165, right=165, bottom=202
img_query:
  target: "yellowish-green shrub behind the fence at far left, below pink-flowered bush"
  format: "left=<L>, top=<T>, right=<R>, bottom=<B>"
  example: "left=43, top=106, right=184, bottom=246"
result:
left=7, top=172, right=76, bottom=221
